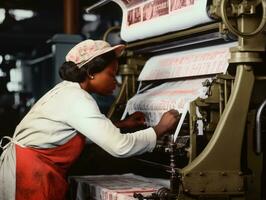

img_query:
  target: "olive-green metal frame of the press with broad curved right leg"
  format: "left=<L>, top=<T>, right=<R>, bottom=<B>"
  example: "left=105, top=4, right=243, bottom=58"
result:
left=108, top=0, right=266, bottom=200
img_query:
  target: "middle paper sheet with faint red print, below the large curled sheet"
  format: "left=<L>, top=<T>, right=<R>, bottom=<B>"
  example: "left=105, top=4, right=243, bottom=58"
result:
left=138, top=42, right=236, bottom=81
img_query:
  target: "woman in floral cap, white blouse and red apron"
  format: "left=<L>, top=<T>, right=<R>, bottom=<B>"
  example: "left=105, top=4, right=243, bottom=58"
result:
left=0, top=40, right=179, bottom=200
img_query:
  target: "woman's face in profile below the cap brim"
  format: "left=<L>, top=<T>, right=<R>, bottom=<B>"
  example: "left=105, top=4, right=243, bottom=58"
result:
left=90, top=60, right=118, bottom=95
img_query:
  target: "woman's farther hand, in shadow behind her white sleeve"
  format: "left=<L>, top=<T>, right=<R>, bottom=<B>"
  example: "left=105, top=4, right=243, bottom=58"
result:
left=114, top=112, right=145, bottom=129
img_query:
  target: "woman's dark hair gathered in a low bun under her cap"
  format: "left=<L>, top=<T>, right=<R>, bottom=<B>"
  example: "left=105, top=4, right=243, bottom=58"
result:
left=59, top=51, right=116, bottom=82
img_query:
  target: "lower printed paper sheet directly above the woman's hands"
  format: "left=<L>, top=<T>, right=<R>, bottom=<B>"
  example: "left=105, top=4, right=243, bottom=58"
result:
left=126, top=78, right=211, bottom=126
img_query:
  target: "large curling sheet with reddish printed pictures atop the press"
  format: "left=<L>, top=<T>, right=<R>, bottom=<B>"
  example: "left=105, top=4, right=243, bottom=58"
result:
left=113, top=0, right=212, bottom=42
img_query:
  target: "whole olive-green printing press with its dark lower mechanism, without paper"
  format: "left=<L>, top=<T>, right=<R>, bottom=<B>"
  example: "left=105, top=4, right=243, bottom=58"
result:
left=70, top=0, right=266, bottom=200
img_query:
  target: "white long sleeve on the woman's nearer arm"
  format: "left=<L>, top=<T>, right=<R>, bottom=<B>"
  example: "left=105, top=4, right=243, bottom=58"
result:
left=67, top=90, right=156, bottom=157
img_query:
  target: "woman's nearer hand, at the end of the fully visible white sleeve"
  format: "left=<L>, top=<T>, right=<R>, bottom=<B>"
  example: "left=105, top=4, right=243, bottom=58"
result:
left=153, top=110, right=180, bottom=138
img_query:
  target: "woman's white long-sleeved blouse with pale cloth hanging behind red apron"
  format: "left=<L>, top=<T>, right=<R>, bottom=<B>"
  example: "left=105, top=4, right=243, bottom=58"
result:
left=0, top=81, right=156, bottom=200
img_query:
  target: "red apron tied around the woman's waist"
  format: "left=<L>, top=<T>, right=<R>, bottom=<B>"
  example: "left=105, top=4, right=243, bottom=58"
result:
left=16, top=134, right=85, bottom=200
